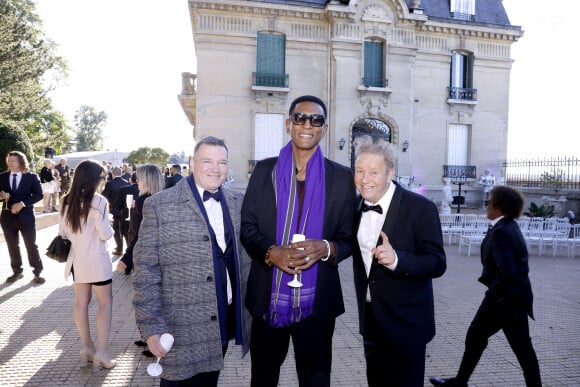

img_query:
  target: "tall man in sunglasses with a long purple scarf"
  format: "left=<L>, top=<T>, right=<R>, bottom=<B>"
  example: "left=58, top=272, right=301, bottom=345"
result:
left=241, top=96, right=355, bottom=387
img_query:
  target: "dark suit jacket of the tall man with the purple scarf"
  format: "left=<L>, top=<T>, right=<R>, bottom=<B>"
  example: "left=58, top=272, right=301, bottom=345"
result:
left=240, top=158, right=356, bottom=320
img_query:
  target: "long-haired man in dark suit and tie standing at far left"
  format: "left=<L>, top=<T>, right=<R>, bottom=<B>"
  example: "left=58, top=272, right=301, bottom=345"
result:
left=0, top=151, right=45, bottom=284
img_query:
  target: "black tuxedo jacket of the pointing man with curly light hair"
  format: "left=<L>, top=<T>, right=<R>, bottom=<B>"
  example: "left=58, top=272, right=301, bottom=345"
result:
left=353, top=182, right=447, bottom=347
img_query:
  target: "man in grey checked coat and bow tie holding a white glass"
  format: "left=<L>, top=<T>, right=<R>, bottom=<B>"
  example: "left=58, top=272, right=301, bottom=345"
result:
left=133, top=137, right=251, bottom=386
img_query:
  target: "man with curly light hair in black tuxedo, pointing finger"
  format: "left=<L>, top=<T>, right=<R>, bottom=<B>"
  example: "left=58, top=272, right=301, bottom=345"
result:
left=353, top=136, right=447, bottom=387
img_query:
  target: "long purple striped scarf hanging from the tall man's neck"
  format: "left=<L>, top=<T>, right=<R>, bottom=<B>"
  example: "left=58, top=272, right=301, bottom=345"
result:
left=266, top=142, right=326, bottom=327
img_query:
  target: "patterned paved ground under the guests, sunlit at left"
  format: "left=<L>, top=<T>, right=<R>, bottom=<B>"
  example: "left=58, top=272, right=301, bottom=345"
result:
left=0, top=226, right=580, bottom=386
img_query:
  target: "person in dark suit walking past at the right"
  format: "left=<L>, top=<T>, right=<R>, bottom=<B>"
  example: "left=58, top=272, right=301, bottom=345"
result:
left=430, top=186, right=542, bottom=387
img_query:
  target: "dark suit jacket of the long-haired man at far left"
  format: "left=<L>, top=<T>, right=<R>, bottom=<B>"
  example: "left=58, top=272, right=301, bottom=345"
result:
left=0, top=172, right=42, bottom=215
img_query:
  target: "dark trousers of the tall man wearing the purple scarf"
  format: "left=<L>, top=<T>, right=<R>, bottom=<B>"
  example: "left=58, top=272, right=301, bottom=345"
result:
left=250, top=317, right=335, bottom=387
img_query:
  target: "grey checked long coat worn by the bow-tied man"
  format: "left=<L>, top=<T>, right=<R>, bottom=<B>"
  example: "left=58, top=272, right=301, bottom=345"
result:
left=133, top=179, right=251, bottom=380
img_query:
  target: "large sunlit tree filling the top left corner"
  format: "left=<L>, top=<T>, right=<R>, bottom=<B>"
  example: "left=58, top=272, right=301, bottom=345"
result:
left=0, top=0, right=67, bottom=126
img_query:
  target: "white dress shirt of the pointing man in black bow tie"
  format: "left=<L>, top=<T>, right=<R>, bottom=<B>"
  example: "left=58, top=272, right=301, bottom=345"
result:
left=356, top=183, right=398, bottom=302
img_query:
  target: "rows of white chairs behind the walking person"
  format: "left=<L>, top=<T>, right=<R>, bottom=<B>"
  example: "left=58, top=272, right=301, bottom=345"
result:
left=439, top=214, right=580, bottom=257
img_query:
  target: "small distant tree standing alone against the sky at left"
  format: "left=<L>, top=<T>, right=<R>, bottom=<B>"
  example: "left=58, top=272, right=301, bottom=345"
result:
left=75, top=105, right=107, bottom=152
